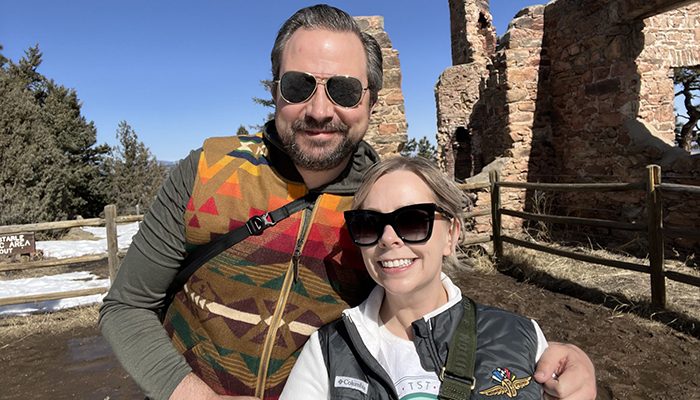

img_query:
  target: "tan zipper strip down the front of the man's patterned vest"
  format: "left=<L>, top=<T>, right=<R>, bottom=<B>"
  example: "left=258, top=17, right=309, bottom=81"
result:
left=255, top=196, right=320, bottom=399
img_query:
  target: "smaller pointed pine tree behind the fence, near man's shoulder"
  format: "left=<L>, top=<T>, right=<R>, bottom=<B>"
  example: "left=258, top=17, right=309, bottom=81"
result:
left=106, top=121, right=166, bottom=213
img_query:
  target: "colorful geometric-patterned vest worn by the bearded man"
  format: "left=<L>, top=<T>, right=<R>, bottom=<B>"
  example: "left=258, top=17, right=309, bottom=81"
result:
left=164, top=136, right=373, bottom=399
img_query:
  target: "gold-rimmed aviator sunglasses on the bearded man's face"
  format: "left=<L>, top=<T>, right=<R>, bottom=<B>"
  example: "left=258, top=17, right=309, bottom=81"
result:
left=275, top=71, right=369, bottom=108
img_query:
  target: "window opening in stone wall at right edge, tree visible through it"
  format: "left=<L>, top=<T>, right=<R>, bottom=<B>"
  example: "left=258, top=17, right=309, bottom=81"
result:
left=673, top=65, right=700, bottom=154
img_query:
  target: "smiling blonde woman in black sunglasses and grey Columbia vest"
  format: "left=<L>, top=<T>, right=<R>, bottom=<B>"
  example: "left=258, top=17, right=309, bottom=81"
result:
left=281, top=157, right=547, bottom=399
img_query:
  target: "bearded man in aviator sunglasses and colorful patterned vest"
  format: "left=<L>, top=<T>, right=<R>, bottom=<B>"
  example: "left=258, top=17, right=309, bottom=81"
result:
left=100, top=5, right=595, bottom=400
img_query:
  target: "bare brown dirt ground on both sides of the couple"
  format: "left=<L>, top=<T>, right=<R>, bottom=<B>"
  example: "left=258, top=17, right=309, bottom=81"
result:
left=0, top=264, right=700, bottom=400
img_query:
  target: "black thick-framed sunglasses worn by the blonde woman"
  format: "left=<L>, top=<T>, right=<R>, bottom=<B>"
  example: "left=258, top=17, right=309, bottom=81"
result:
left=344, top=203, right=452, bottom=246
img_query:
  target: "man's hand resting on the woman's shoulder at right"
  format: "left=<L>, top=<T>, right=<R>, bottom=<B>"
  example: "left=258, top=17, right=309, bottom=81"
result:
left=535, top=342, right=596, bottom=400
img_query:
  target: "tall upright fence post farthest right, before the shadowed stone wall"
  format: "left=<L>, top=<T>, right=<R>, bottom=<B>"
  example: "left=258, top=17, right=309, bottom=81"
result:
left=647, top=165, right=666, bottom=308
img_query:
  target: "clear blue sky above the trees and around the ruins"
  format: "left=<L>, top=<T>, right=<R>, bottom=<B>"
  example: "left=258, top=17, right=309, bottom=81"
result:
left=0, top=0, right=546, bottom=161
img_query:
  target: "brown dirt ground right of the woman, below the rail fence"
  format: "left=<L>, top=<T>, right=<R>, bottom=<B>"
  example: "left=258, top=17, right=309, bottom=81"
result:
left=457, top=273, right=700, bottom=400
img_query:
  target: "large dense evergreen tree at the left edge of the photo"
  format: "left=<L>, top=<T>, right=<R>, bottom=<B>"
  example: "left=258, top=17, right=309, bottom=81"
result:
left=0, top=46, right=108, bottom=225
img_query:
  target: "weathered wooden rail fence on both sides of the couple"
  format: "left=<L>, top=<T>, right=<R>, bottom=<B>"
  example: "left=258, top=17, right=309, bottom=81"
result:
left=0, top=165, right=700, bottom=308
